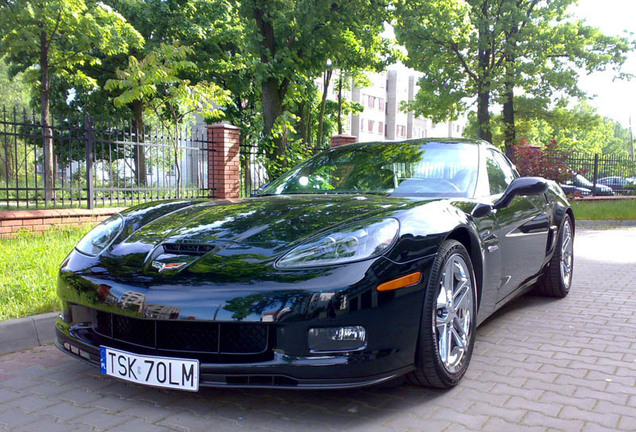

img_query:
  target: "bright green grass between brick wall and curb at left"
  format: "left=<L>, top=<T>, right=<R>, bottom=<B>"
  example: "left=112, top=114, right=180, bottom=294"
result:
left=0, top=226, right=90, bottom=320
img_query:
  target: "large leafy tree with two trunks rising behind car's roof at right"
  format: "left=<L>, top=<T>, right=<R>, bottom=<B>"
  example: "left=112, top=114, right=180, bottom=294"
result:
left=396, top=0, right=632, bottom=154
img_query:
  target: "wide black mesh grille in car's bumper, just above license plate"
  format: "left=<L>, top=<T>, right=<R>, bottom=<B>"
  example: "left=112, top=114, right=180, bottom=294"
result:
left=93, top=311, right=270, bottom=355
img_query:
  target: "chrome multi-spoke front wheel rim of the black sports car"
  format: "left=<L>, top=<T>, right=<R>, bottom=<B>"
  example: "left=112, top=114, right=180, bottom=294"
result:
left=434, top=254, right=475, bottom=373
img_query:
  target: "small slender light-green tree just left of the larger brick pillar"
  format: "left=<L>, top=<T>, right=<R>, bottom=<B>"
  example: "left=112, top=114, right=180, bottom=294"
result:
left=106, top=44, right=229, bottom=197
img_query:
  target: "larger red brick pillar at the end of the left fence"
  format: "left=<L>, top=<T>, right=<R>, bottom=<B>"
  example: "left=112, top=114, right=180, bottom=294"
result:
left=206, top=123, right=240, bottom=198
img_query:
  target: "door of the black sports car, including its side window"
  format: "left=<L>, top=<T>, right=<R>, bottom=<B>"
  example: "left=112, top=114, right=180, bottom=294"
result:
left=485, top=148, right=550, bottom=302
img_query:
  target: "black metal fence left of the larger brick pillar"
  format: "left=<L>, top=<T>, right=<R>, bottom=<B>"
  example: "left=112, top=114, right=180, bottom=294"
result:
left=0, top=110, right=214, bottom=210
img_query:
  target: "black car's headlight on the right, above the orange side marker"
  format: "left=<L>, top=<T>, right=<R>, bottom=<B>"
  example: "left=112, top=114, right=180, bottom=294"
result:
left=277, top=219, right=400, bottom=268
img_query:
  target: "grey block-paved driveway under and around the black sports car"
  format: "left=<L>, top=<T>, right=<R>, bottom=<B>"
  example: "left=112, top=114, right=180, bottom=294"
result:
left=0, top=228, right=636, bottom=432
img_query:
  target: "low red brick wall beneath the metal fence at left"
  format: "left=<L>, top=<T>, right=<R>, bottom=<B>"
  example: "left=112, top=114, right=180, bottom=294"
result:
left=0, top=207, right=125, bottom=238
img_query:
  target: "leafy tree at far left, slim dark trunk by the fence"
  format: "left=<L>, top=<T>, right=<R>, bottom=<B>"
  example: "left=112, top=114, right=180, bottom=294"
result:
left=0, top=0, right=142, bottom=202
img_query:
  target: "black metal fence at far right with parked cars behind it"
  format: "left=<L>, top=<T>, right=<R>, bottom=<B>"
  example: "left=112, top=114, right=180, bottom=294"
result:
left=565, top=153, right=636, bottom=195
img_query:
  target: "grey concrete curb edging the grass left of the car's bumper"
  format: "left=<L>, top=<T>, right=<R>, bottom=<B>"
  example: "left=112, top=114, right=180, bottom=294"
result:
left=0, top=312, right=59, bottom=355
